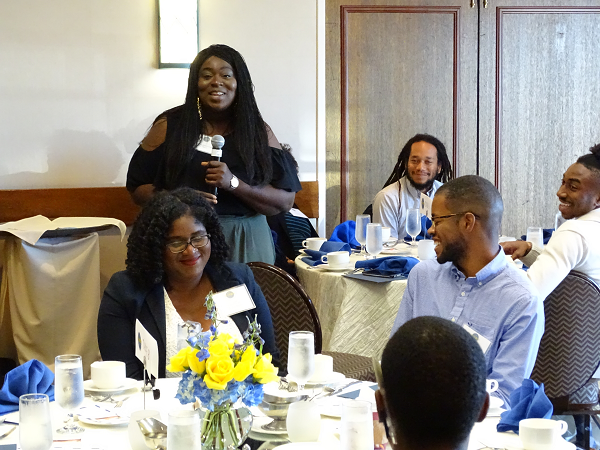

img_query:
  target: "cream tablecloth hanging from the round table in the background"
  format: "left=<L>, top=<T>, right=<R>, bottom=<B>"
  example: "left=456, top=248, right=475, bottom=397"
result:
left=296, top=244, right=417, bottom=357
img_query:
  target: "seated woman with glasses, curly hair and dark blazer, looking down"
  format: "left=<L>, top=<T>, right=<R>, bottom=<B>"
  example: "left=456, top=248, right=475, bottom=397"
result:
left=98, top=188, right=279, bottom=379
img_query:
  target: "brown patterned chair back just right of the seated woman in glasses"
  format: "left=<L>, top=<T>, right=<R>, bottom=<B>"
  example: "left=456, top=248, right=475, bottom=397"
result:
left=248, top=262, right=322, bottom=373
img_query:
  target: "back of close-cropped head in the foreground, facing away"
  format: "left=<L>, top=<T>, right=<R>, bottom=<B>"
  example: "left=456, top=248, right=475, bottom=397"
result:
left=380, top=316, right=487, bottom=449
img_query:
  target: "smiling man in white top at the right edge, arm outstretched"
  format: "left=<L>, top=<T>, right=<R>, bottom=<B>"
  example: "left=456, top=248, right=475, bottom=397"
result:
left=501, top=144, right=600, bottom=298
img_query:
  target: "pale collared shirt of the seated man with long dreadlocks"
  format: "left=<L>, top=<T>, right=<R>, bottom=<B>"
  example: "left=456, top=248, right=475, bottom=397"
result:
left=373, top=176, right=442, bottom=239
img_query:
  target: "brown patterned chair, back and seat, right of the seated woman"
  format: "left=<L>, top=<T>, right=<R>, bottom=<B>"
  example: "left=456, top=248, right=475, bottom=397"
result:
left=248, top=262, right=375, bottom=381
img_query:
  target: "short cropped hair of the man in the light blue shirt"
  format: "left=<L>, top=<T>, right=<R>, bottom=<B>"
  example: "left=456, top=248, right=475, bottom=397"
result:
left=435, top=175, right=504, bottom=238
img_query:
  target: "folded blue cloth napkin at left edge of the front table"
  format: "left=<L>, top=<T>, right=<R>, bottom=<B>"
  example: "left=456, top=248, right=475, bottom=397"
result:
left=0, top=359, right=54, bottom=415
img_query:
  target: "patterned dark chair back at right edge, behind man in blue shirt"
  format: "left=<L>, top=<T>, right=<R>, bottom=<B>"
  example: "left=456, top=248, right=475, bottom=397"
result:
left=531, top=271, right=600, bottom=402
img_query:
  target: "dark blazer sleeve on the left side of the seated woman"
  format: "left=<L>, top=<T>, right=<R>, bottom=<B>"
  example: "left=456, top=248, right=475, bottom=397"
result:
left=97, top=272, right=143, bottom=380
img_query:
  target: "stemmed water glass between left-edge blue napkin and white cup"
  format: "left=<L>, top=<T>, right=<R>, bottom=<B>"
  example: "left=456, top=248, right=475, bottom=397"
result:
left=54, top=355, right=85, bottom=434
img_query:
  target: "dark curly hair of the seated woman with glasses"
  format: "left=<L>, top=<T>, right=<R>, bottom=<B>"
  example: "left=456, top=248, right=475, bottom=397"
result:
left=125, top=188, right=229, bottom=288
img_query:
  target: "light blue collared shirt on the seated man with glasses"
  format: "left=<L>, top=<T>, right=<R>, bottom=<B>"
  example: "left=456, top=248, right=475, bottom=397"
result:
left=392, top=248, right=544, bottom=404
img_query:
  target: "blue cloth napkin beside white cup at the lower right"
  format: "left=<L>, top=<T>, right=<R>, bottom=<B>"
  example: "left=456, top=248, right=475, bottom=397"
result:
left=496, top=378, right=554, bottom=434
